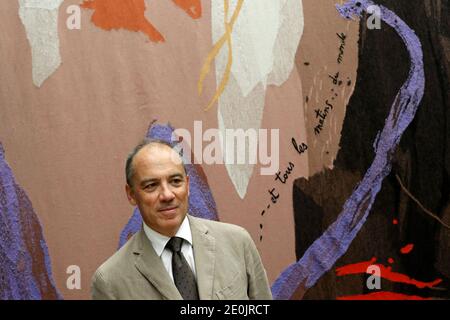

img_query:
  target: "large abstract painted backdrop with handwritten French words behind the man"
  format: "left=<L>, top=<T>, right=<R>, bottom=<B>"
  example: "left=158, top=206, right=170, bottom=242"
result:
left=0, top=0, right=450, bottom=299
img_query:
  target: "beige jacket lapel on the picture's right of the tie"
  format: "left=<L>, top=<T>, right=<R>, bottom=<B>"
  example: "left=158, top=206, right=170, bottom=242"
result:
left=188, top=216, right=216, bottom=300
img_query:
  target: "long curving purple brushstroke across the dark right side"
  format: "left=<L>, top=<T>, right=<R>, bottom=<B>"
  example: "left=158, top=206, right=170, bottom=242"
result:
left=272, top=0, right=425, bottom=300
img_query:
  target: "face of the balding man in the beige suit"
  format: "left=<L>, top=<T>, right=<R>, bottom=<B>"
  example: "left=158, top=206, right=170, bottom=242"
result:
left=126, top=143, right=189, bottom=237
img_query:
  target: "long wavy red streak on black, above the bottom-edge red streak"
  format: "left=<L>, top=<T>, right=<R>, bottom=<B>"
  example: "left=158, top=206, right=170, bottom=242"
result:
left=336, top=258, right=442, bottom=289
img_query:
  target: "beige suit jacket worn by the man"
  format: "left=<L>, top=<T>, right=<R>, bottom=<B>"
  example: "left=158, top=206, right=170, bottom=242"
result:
left=91, top=215, right=272, bottom=300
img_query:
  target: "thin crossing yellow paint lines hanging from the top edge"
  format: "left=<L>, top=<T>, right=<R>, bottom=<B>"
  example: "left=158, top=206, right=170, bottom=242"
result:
left=197, top=0, right=244, bottom=111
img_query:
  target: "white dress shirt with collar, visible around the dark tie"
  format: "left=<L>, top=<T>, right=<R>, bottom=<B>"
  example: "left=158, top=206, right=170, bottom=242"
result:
left=144, top=216, right=197, bottom=281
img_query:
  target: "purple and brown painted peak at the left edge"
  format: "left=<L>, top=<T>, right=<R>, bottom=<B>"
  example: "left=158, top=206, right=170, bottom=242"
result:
left=0, top=143, right=62, bottom=300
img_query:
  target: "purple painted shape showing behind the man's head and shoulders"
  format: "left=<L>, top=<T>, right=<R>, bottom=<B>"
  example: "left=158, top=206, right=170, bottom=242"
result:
left=119, top=124, right=219, bottom=248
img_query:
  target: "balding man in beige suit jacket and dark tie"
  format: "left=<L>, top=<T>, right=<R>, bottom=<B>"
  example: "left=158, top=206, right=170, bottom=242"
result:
left=92, top=140, right=272, bottom=300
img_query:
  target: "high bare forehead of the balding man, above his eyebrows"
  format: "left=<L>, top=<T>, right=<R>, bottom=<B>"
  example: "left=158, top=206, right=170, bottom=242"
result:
left=133, top=143, right=184, bottom=176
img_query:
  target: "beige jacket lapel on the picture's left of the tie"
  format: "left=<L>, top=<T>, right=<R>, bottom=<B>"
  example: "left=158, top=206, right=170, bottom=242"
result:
left=133, top=229, right=183, bottom=300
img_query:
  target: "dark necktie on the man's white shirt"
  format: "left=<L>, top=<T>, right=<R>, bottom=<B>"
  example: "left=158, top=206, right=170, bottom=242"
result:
left=166, top=237, right=198, bottom=300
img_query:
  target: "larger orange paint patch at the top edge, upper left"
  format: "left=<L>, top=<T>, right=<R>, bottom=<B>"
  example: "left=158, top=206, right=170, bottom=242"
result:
left=81, top=0, right=164, bottom=42
